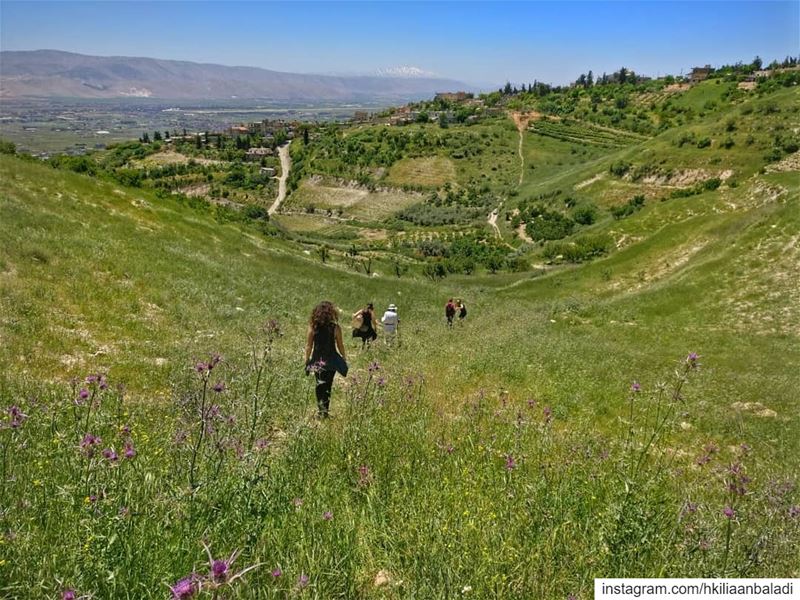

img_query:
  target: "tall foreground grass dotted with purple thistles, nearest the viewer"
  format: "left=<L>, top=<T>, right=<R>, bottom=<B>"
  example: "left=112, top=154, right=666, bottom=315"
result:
left=0, top=330, right=800, bottom=598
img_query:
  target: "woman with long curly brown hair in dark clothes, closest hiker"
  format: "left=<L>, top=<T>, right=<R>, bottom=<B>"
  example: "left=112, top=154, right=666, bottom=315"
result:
left=305, top=300, right=347, bottom=419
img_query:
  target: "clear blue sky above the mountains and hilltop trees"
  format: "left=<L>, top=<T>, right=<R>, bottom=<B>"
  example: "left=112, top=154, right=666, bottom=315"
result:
left=0, top=0, right=800, bottom=84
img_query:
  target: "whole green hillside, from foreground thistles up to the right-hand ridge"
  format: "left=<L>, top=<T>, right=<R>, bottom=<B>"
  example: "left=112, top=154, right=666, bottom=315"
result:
left=0, top=81, right=800, bottom=598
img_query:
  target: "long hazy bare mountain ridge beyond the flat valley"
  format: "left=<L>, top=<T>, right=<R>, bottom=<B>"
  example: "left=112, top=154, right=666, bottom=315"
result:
left=0, top=50, right=471, bottom=100
